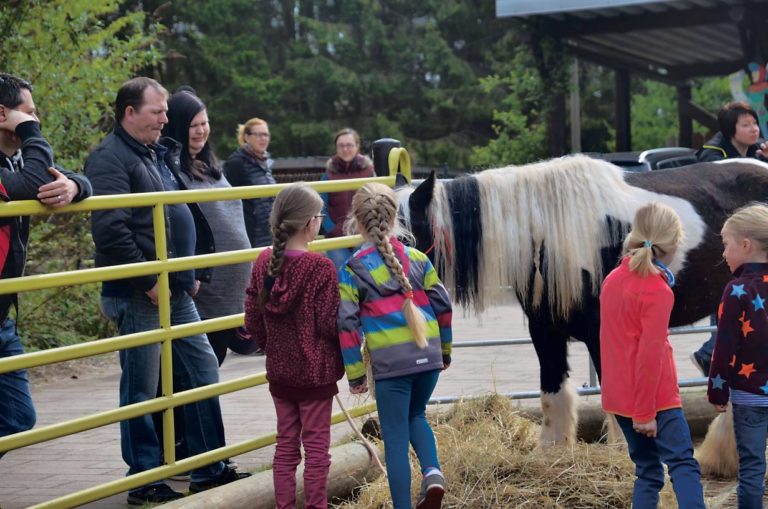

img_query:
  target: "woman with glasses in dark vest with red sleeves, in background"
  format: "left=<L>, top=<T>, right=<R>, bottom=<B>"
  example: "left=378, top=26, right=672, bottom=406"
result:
left=322, top=127, right=374, bottom=269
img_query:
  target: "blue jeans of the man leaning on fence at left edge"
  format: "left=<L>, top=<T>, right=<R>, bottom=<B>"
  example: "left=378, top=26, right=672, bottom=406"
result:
left=0, top=318, right=36, bottom=457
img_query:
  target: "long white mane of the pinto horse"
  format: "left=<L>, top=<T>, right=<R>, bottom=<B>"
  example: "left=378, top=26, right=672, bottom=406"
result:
left=430, top=155, right=640, bottom=317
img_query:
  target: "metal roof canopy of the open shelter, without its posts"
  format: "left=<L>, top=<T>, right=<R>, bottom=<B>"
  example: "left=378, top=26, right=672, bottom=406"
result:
left=496, top=0, right=768, bottom=84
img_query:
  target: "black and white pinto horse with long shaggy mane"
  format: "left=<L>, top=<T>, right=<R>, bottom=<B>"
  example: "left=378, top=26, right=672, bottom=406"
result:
left=398, top=155, right=768, bottom=444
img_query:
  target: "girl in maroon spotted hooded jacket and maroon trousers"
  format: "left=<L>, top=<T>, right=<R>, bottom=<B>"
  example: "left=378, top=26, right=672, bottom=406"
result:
left=245, top=183, right=344, bottom=509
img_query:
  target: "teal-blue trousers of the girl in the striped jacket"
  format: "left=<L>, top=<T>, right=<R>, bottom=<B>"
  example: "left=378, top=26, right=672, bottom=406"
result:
left=376, top=369, right=440, bottom=509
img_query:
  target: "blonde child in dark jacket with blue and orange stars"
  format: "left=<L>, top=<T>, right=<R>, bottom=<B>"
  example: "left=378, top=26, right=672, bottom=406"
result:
left=707, top=205, right=768, bottom=508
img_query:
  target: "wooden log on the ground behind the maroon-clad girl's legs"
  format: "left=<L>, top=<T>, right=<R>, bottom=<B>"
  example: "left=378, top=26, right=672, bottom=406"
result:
left=163, top=442, right=383, bottom=509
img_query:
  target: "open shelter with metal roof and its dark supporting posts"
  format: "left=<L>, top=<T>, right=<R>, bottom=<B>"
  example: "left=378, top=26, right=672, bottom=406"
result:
left=496, top=0, right=768, bottom=155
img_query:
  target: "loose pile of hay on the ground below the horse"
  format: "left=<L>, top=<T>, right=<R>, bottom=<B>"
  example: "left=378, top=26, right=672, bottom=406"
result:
left=338, top=395, right=688, bottom=509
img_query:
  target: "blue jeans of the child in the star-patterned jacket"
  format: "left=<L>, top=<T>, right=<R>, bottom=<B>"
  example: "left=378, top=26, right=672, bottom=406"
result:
left=733, top=404, right=768, bottom=509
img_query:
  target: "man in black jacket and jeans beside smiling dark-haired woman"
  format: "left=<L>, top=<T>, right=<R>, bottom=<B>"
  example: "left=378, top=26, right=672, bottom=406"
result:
left=85, top=77, right=246, bottom=505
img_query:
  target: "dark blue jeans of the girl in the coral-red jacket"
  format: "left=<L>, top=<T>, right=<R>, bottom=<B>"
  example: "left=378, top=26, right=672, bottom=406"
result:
left=616, top=408, right=706, bottom=509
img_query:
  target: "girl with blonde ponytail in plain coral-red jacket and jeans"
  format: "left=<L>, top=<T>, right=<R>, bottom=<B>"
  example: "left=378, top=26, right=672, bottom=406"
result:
left=600, top=203, right=706, bottom=509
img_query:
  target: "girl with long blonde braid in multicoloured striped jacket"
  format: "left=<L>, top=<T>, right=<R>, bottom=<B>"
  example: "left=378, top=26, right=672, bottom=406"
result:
left=338, top=184, right=451, bottom=509
